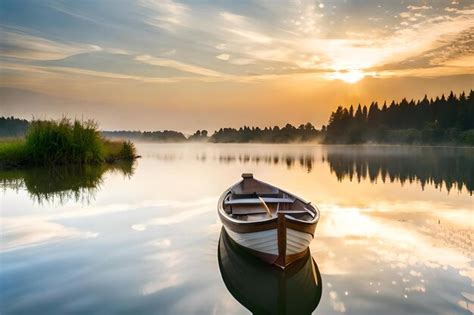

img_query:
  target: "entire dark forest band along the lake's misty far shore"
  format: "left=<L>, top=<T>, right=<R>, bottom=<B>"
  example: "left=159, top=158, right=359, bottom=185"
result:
left=0, top=90, right=474, bottom=145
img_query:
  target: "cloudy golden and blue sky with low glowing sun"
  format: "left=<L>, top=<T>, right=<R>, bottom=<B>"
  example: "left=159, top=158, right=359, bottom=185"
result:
left=0, top=0, right=474, bottom=133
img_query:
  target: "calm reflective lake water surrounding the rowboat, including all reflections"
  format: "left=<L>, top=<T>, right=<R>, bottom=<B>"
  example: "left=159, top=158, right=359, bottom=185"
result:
left=0, top=144, right=474, bottom=314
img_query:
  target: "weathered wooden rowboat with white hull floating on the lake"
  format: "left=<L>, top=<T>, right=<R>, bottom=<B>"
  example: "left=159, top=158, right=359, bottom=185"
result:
left=217, top=174, right=319, bottom=268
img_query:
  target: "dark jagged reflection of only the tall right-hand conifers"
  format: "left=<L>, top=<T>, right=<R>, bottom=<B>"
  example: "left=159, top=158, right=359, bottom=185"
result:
left=327, top=147, right=474, bottom=194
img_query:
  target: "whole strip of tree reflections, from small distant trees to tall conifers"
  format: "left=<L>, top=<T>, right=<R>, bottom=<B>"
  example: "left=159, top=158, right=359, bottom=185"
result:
left=193, top=146, right=474, bottom=195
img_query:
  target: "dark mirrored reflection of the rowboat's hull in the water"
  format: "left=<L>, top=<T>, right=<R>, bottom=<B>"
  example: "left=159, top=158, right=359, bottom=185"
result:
left=218, top=228, right=322, bottom=314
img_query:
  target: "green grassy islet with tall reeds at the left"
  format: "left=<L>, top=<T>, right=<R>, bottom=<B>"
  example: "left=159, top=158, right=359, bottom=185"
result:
left=0, top=118, right=138, bottom=168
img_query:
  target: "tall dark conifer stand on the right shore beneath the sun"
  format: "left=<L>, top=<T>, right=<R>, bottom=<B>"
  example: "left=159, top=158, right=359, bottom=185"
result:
left=323, top=90, right=474, bottom=145
